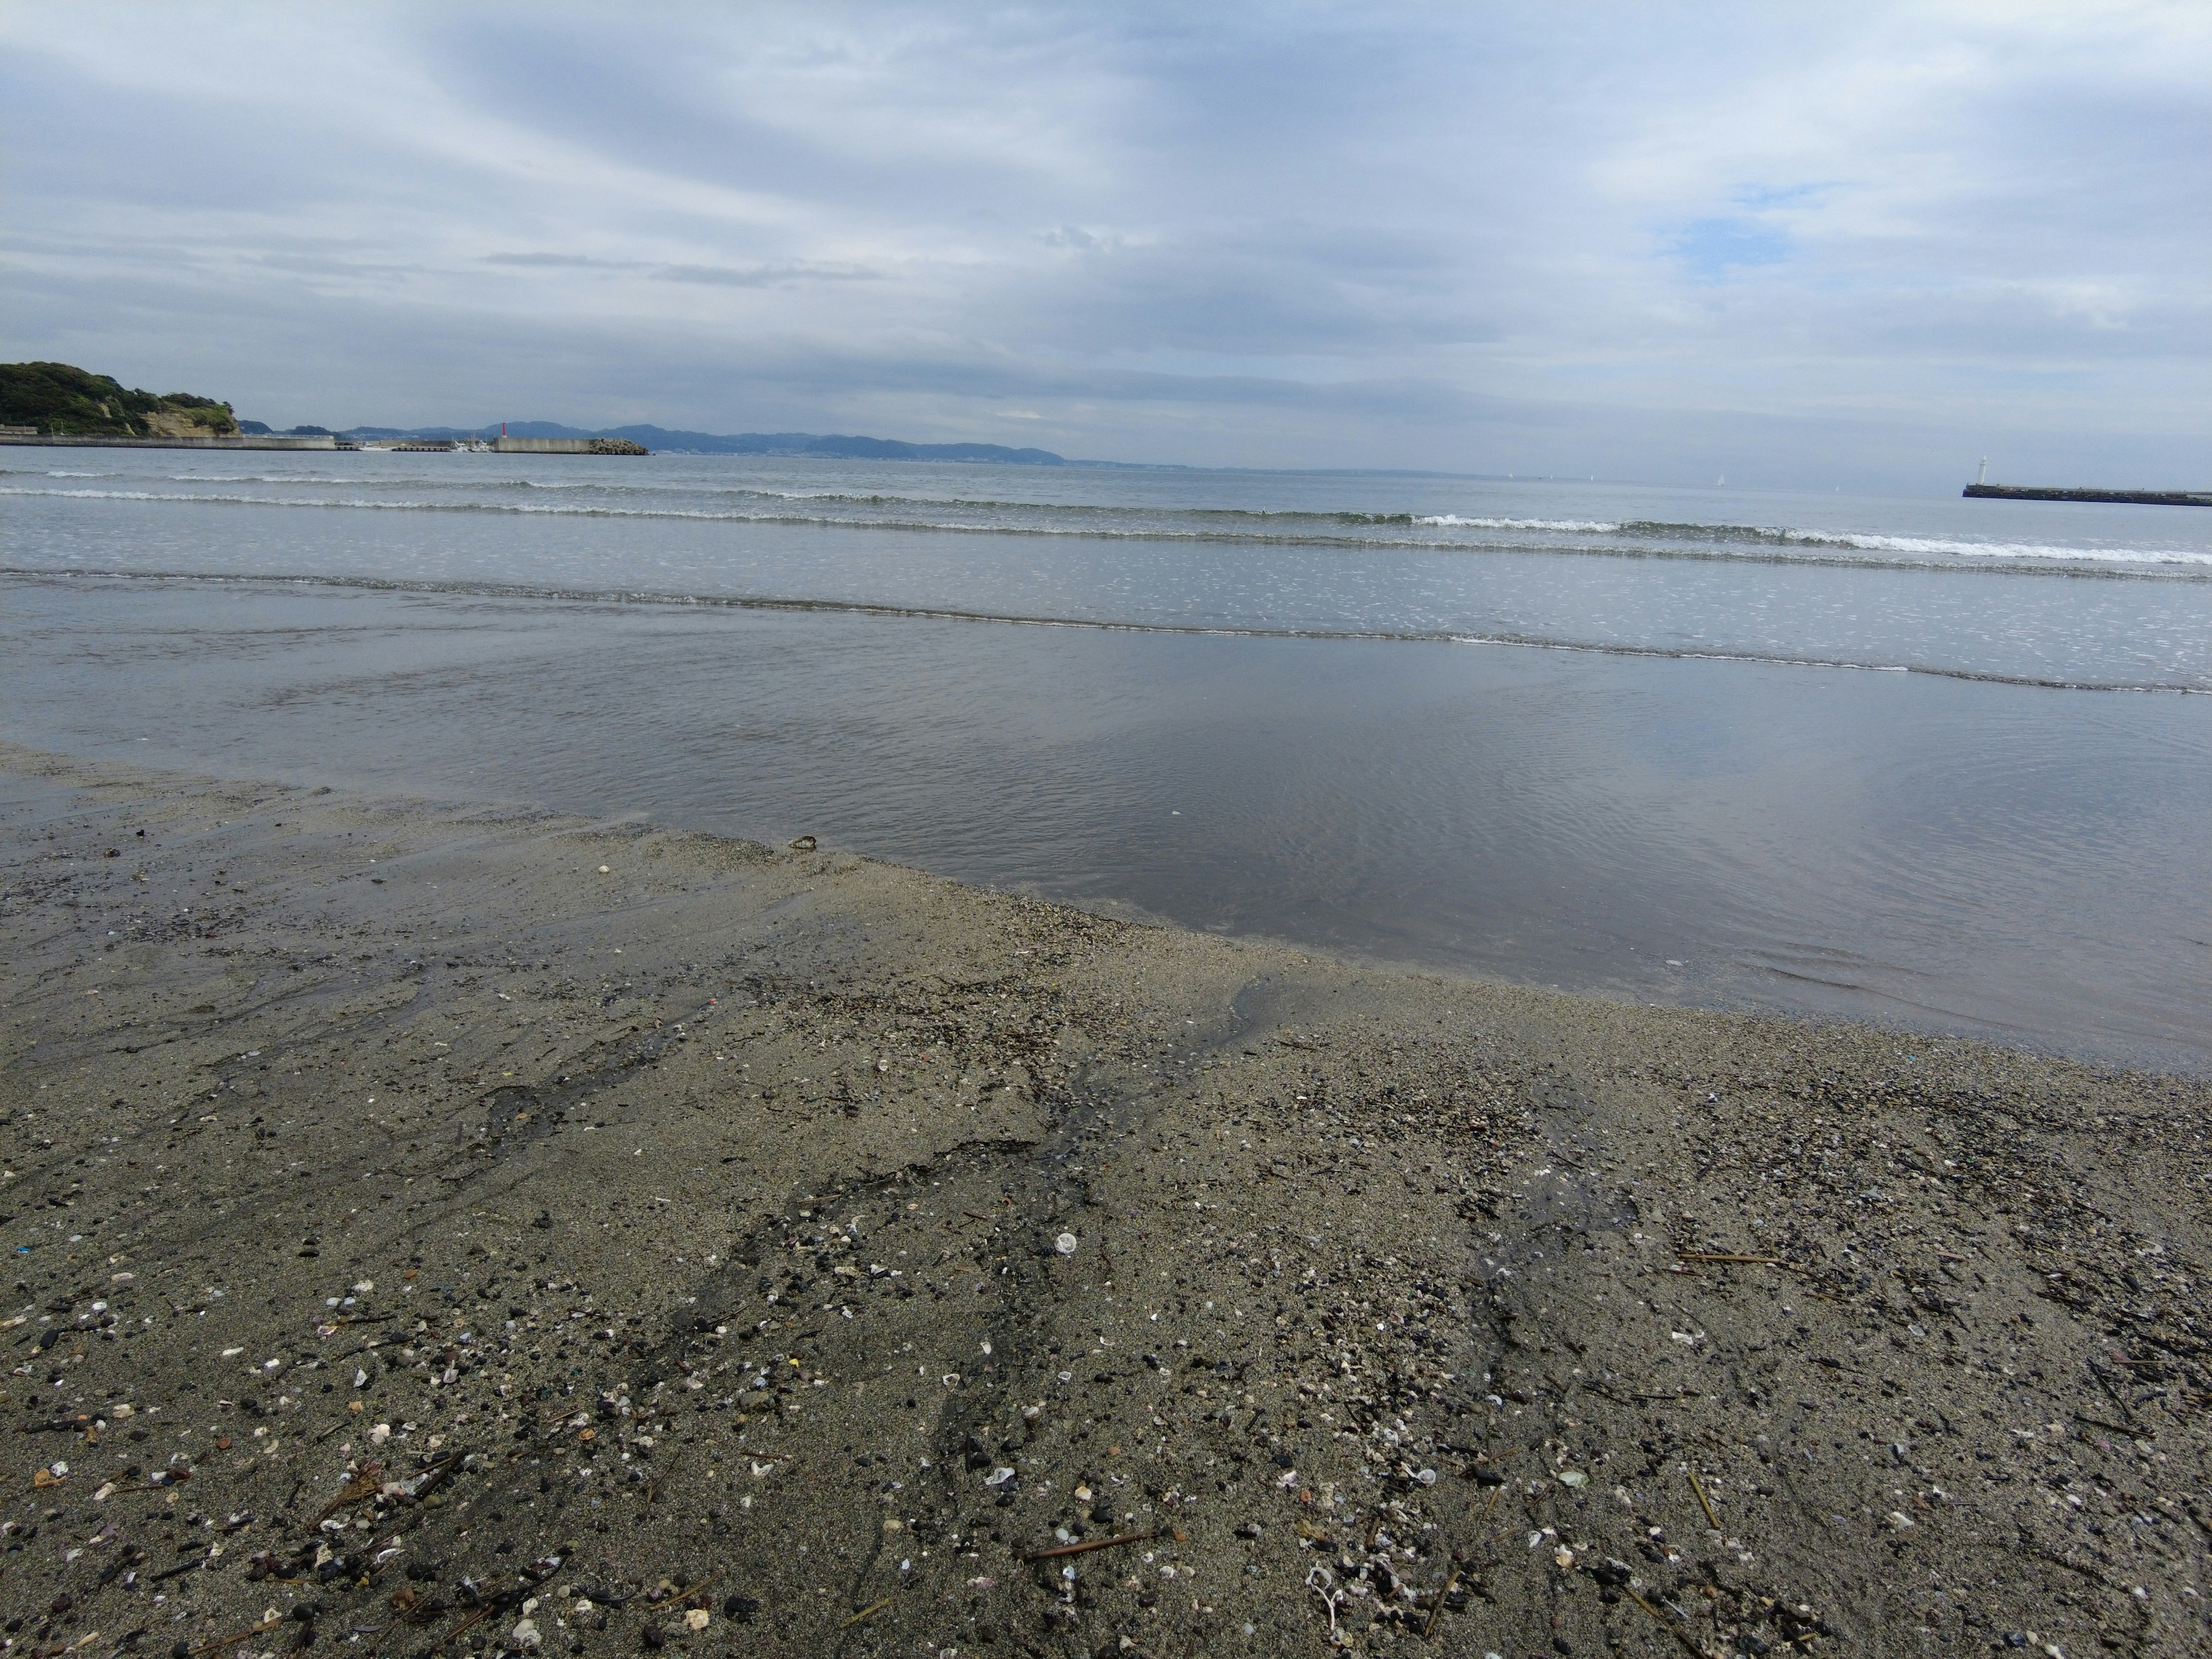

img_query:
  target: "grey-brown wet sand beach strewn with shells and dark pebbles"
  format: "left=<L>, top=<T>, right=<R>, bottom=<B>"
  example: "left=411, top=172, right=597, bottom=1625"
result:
left=0, top=750, right=2212, bottom=1659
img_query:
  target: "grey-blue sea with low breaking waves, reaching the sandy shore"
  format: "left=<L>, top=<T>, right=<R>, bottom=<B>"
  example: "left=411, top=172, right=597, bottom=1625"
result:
left=0, top=449, right=2212, bottom=1069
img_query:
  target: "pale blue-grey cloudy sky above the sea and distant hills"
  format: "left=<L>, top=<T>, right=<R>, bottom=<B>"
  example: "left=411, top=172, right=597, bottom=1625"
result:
left=0, top=0, right=2212, bottom=489
